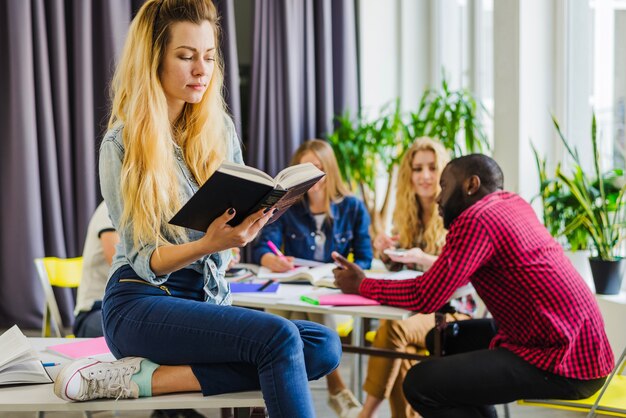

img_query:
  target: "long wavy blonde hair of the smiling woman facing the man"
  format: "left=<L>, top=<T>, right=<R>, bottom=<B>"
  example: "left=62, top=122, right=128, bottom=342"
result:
left=393, top=137, right=450, bottom=255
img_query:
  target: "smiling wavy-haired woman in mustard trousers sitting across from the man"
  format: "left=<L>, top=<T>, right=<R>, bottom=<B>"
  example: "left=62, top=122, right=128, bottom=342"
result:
left=350, top=137, right=471, bottom=418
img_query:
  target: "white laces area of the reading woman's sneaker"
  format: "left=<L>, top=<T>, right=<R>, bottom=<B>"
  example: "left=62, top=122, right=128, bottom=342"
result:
left=81, top=366, right=136, bottom=400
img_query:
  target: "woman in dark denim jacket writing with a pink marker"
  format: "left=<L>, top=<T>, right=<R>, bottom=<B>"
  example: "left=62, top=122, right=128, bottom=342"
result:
left=252, top=139, right=372, bottom=417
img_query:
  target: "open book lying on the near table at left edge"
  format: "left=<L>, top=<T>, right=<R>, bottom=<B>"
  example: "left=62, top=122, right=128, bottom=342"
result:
left=0, top=325, right=52, bottom=385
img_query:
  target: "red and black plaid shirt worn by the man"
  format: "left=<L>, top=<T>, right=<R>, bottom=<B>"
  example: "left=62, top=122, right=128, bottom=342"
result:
left=359, top=192, right=614, bottom=380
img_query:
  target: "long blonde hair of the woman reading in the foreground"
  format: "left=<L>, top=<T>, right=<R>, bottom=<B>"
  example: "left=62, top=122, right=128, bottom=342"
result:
left=109, top=0, right=227, bottom=245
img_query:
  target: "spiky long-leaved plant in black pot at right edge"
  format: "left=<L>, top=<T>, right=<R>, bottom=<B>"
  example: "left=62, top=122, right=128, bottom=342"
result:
left=552, top=114, right=626, bottom=294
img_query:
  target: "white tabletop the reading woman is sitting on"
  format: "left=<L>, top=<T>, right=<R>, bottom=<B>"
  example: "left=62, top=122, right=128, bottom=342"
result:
left=0, top=338, right=264, bottom=411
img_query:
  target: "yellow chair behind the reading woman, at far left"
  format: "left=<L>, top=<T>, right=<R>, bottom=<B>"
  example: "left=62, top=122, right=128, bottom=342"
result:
left=35, top=257, right=83, bottom=337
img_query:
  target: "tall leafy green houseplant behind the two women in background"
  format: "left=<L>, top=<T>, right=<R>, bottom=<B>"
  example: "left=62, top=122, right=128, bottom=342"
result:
left=327, top=79, right=490, bottom=235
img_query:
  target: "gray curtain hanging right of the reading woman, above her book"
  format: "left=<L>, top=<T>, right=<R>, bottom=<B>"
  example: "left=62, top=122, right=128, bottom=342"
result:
left=246, top=0, right=359, bottom=175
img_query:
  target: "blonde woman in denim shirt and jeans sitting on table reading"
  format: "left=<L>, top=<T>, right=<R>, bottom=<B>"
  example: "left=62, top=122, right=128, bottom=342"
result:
left=54, top=0, right=341, bottom=418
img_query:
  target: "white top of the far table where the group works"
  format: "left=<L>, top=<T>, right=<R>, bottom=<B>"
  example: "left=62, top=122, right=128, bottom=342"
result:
left=233, top=283, right=413, bottom=320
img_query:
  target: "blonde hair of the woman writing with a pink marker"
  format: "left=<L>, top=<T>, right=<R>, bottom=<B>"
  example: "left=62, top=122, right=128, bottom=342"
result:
left=291, top=139, right=350, bottom=220
